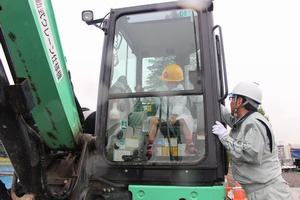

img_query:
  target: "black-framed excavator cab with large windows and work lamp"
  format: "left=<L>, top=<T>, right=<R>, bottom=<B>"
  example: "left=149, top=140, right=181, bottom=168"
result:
left=83, top=1, right=227, bottom=199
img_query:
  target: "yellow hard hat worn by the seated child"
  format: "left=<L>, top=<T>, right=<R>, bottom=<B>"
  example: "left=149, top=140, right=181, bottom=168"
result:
left=160, top=64, right=183, bottom=82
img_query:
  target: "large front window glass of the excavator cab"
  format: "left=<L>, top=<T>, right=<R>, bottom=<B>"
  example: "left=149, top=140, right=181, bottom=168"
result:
left=105, top=10, right=206, bottom=165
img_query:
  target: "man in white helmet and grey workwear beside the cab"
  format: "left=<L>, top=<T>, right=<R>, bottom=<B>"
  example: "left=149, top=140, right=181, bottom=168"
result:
left=212, top=82, right=293, bottom=200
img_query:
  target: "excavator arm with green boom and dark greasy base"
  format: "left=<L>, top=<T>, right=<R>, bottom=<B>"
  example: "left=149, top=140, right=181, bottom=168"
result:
left=0, top=0, right=95, bottom=199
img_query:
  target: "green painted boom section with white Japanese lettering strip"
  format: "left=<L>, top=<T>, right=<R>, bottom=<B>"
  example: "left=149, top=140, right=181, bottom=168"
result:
left=0, top=0, right=81, bottom=149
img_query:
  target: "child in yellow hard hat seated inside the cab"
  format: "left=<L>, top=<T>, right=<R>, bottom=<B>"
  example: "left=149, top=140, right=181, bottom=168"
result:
left=146, top=64, right=198, bottom=157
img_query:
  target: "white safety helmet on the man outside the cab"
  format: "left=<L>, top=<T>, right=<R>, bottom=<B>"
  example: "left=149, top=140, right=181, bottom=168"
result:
left=232, top=81, right=262, bottom=108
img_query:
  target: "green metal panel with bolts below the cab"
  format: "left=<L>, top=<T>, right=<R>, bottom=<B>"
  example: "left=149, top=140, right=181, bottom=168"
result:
left=129, top=185, right=225, bottom=200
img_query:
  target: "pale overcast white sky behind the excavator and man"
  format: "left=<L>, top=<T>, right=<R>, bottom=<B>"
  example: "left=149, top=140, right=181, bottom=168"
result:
left=52, top=0, right=300, bottom=145
